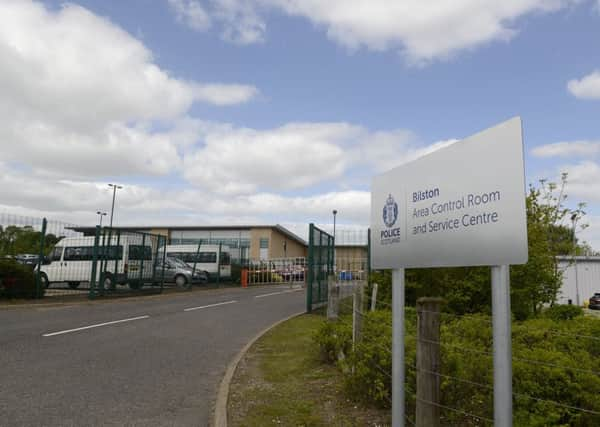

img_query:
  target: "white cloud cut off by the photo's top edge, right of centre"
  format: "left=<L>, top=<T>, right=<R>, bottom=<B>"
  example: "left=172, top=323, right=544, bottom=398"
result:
left=195, top=0, right=577, bottom=64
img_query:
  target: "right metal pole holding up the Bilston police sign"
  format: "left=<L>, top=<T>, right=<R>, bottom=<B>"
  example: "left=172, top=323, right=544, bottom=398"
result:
left=492, top=265, right=512, bottom=427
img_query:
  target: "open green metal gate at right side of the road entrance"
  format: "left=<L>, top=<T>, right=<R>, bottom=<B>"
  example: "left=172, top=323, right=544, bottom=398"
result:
left=306, top=223, right=335, bottom=313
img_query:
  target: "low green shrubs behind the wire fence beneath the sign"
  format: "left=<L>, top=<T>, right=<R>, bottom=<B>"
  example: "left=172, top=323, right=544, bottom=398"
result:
left=317, top=308, right=600, bottom=427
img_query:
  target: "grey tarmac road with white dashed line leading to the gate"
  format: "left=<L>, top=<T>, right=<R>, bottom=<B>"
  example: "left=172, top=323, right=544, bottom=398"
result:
left=0, top=287, right=305, bottom=427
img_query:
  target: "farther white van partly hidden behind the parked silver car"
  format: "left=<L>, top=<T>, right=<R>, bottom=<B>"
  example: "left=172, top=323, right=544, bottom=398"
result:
left=167, top=245, right=231, bottom=280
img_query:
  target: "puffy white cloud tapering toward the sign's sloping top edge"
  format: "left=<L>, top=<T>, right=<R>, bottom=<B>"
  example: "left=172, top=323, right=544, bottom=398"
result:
left=184, top=122, right=453, bottom=194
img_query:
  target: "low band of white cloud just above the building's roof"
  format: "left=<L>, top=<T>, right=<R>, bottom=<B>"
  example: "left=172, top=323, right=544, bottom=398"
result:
left=0, top=163, right=370, bottom=226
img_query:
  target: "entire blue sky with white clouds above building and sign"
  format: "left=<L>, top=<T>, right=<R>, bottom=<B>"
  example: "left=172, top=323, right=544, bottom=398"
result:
left=0, top=0, right=600, bottom=250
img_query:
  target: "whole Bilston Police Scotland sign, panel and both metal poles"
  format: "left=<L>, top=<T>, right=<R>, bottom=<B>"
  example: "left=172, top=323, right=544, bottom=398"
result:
left=370, top=117, right=528, bottom=427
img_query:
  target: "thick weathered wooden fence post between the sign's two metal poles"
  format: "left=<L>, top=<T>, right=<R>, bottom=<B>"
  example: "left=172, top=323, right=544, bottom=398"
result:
left=416, top=298, right=443, bottom=427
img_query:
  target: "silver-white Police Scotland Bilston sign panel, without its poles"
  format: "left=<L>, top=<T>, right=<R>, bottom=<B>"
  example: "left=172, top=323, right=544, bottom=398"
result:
left=371, top=118, right=527, bottom=269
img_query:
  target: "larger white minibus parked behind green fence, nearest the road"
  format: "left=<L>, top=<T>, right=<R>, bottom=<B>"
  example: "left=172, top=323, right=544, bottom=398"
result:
left=40, top=235, right=154, bottom=289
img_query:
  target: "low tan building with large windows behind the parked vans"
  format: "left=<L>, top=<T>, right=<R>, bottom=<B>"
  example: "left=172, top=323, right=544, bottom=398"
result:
left=74, top=224, right=307, bottom=262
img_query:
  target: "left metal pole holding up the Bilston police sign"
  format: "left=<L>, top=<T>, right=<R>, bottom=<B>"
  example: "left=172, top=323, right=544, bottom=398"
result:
left=392, top=268, right=404, bottom=427
